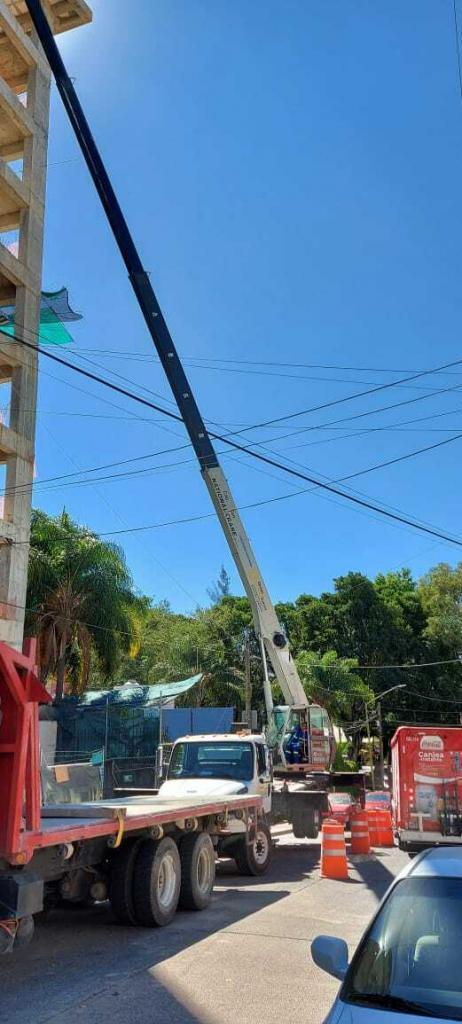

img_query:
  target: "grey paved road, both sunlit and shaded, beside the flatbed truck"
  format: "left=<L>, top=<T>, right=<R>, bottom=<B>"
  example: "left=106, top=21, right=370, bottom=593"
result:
left=0, top=836, right=406, bottom=1024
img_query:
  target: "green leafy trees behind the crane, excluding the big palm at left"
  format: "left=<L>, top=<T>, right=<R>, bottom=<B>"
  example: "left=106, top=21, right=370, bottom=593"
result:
left=113, top=565, right=462, bottom=735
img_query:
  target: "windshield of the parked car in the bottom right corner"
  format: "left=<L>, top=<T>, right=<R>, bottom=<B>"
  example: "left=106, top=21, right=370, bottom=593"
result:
left=341, top=878, right=462, bottom=1020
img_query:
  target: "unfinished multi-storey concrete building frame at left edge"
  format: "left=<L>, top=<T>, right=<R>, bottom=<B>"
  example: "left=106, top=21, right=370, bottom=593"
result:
left=0, top=0, right=91, bottom=647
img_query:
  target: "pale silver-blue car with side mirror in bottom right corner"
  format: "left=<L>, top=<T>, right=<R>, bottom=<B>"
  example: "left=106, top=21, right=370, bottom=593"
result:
left=311, top=847, right=462, bottom=1024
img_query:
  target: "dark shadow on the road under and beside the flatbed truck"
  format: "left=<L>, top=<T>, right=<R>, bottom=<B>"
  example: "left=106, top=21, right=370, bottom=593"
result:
left=0, top=844, right=320, bottom=1024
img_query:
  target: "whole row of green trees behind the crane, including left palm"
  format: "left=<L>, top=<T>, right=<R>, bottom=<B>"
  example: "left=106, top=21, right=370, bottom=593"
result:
left=27, top=511, right=462, bottom=735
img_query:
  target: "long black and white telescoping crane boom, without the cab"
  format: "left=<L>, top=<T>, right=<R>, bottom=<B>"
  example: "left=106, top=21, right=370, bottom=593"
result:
left=26, top=0, right=333, bottom=761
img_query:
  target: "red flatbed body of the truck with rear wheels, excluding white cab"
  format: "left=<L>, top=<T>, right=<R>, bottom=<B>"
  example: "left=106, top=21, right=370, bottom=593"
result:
left=0, top=641, right=263, bottom=953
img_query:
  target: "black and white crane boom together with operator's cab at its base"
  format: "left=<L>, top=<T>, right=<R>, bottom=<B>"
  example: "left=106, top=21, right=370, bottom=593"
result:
left=26, top=0, right=334, bottom=769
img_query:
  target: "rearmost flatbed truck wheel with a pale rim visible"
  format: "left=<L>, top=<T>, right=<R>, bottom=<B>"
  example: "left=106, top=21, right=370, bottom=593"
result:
left=133, top=836, right=181, bottom=928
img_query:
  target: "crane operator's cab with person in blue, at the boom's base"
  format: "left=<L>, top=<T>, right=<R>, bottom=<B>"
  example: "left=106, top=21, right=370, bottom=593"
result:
left=267, top=705, right=335, bottom=772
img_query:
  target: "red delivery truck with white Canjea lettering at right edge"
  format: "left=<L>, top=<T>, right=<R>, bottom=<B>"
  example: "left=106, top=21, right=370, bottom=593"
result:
left=390, top=725, right=462, bottom=853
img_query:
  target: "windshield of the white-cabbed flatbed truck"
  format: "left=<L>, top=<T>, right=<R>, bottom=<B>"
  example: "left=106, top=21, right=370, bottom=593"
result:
left=167, top=742, right=254, bottom=781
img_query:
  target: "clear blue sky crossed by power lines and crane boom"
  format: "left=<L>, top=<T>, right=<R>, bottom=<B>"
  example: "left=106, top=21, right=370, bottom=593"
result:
left=35, top=0, right=462, bottom=610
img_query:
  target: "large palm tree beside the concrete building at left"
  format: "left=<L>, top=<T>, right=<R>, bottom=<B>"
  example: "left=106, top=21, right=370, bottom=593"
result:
left=26, top=511, right=145, bottom=699
